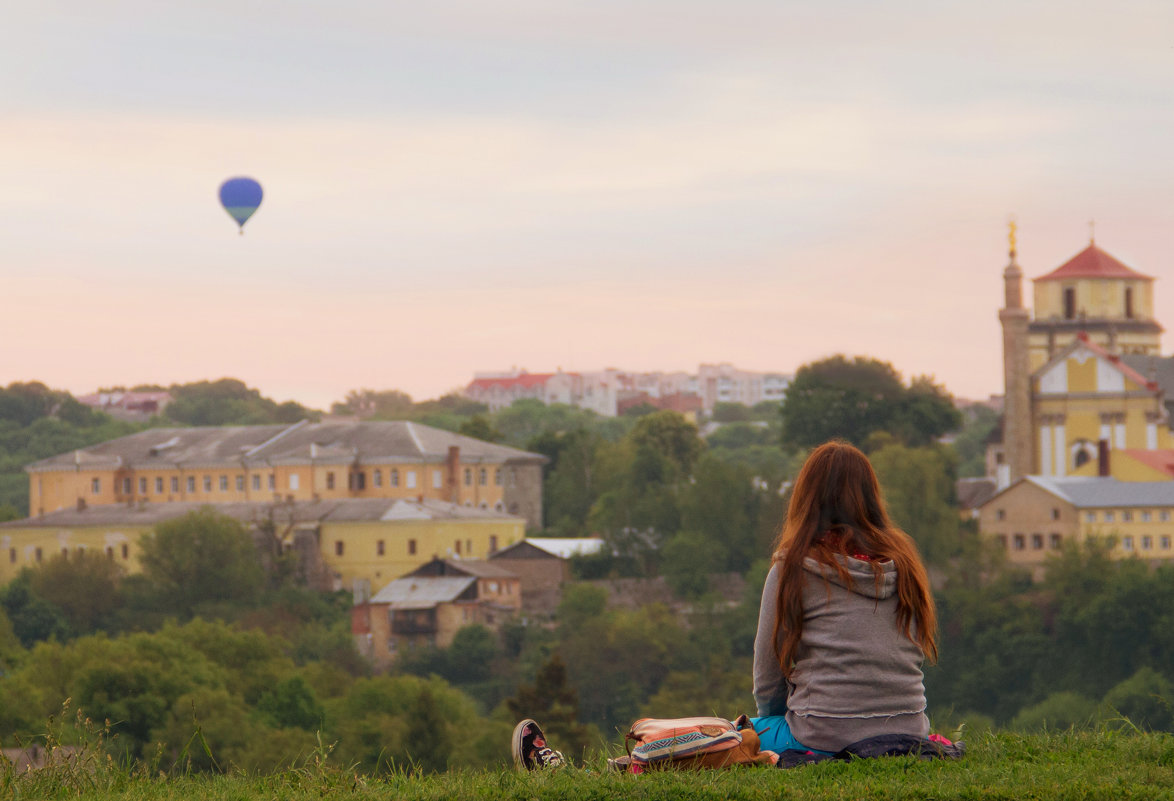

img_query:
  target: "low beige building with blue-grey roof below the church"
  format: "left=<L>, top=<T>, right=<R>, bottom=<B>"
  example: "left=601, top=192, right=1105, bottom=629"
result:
left=978, top=476, right=1174, bottom=567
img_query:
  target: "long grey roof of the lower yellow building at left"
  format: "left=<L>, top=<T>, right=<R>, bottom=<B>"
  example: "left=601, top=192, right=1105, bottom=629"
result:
left=0, top=498, right=522, bottom=529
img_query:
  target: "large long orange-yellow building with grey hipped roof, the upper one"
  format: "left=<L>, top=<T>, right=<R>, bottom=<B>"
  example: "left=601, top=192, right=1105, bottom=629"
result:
left=26, top=420, right=547, bottom=527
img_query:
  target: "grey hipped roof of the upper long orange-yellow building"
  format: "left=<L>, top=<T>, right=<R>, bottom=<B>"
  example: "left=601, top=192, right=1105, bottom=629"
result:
left=25, top=420, right=547, bottom=472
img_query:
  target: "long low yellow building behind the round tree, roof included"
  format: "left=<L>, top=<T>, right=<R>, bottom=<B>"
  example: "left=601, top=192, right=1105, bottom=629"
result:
left=0, top=498, right=526, bottom=589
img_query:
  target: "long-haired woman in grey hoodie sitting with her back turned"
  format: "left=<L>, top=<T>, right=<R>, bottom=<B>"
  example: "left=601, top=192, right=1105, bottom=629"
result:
left=751, top=442, right=937, bottom=754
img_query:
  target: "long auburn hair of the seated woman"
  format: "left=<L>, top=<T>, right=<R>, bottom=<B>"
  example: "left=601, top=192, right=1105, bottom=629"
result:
left=772, top=439, right=938, bottom=677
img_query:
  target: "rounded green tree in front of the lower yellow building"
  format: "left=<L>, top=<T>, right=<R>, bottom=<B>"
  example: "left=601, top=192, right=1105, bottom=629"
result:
left=140, top=507, right=264, bottom=617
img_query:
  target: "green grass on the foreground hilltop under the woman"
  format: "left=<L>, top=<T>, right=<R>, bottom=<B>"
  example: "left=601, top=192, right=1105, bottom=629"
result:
left=9, top=729, right=1174, bottom=801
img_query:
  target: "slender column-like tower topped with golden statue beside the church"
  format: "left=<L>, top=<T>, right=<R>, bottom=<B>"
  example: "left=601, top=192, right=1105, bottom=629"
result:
left=997, top=222, right=1035, bottom=487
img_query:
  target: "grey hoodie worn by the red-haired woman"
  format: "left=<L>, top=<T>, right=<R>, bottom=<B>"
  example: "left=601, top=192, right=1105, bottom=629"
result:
left=754, top=557, right=930, bottom=750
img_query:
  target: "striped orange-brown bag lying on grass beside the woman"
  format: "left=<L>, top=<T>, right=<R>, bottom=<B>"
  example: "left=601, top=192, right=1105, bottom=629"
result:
left=616, top=715, right=778, bottom=773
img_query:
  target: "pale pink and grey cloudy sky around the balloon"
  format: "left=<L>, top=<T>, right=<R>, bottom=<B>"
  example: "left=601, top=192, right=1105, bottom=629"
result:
left=0, top=0, right=1174, bottom=408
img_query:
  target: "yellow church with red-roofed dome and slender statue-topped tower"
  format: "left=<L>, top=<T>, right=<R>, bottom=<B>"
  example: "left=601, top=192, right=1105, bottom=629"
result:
left=987, top=229, right=1174, bottom=489
